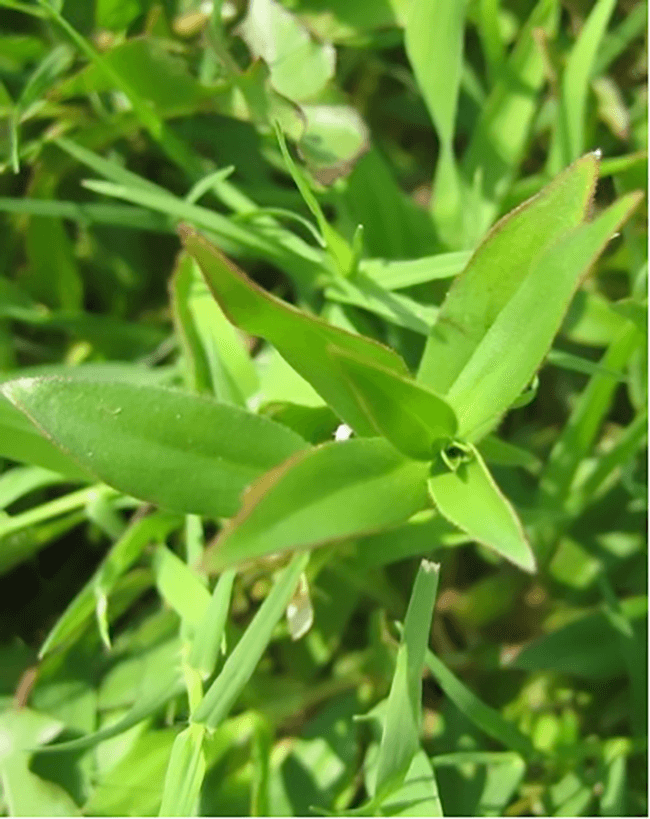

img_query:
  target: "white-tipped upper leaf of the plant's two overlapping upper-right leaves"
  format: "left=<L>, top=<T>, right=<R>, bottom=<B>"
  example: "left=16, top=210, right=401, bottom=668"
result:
left=418, top=154, right=598, bottom=395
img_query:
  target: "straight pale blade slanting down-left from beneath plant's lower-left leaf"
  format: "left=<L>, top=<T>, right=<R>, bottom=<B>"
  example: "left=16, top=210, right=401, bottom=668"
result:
left=192, top=554, right=309, bottom=728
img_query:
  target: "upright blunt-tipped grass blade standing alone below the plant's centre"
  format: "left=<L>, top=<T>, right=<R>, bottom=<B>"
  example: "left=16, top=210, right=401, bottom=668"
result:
left=373, top=560, right=440, bottom=804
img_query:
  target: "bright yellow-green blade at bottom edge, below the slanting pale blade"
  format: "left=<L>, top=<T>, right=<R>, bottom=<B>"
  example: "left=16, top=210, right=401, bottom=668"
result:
left=158, top=724, right=205, bottom=816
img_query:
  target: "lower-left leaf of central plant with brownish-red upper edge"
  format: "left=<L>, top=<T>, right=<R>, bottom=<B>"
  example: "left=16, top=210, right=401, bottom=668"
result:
left=205, top=438, right=428, bottom=571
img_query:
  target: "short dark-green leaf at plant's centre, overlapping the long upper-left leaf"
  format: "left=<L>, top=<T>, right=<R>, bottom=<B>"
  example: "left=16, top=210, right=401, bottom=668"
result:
left=330, top=348, right=457, bottom=461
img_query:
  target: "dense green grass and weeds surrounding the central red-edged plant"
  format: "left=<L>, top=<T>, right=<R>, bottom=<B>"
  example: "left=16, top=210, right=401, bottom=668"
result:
left=0, top=0, right=647, bottom=816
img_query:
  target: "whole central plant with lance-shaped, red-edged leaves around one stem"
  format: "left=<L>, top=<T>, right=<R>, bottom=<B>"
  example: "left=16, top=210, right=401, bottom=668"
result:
left=0, top=154, right=640, bottom=571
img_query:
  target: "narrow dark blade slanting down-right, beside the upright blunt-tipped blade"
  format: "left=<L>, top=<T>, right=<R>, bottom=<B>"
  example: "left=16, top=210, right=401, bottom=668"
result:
left=425, top=651, right=536, bottom=760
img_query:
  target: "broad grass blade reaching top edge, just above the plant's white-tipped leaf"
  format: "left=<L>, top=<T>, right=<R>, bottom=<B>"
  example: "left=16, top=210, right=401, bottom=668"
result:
left=463, top=0, right=561, bottom=247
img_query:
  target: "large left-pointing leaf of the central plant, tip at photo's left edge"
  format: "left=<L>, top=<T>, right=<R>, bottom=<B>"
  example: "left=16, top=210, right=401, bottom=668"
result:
left=1, top=377, right=307, bottom=517
